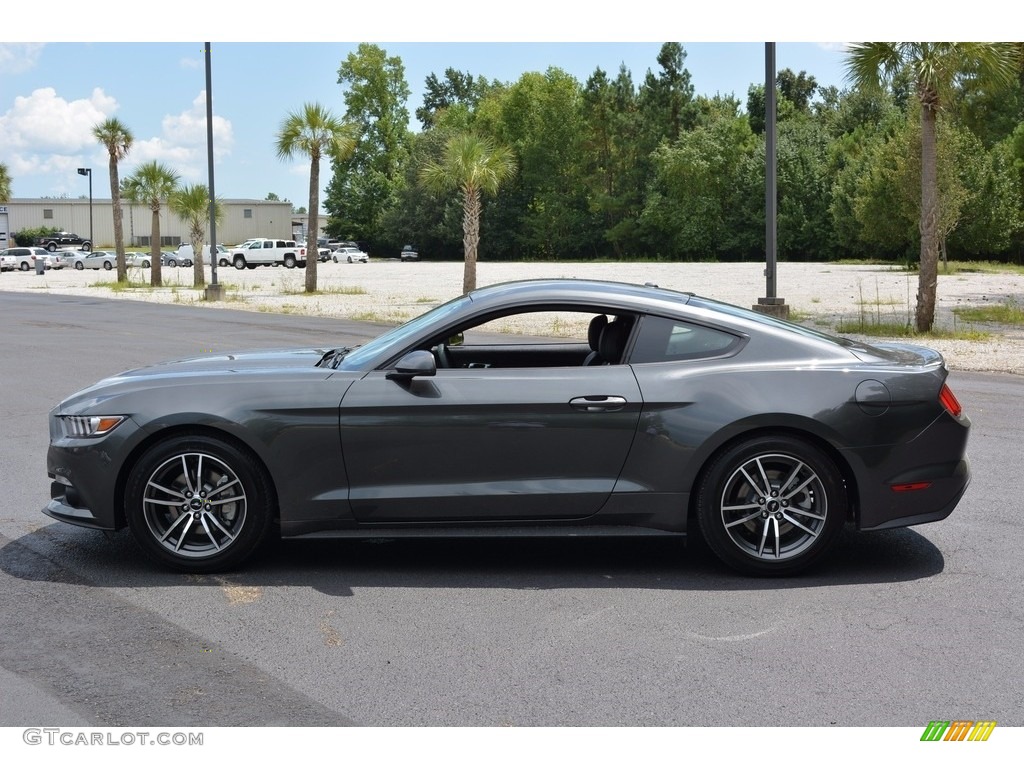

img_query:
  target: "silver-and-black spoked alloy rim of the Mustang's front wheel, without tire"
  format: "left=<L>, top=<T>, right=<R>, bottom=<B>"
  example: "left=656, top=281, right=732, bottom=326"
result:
left=142, top=452, right=248, bottom=558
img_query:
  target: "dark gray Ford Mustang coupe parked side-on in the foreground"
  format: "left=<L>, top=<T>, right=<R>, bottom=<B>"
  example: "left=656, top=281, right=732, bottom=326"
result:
left=44, top=280, right=970, bottom=575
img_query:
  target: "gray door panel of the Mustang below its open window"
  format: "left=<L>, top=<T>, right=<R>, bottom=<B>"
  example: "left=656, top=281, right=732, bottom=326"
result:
left=340, top=366, right=642, bottom=522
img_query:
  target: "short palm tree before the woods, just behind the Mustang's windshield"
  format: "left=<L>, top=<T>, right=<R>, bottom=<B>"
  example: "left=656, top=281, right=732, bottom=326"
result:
left=420, top=133, right=516, bottom=293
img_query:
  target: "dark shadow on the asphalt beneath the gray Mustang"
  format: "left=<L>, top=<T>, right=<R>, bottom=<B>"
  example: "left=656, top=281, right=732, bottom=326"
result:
left=0, top=523, right=945, bottom=596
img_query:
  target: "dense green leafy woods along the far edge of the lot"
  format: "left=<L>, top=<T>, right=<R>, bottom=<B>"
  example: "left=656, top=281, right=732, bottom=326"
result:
left=324, top=43, right=1024, bottom=270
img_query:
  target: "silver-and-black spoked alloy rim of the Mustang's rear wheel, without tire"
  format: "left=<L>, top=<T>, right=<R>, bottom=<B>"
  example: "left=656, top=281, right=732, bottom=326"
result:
left=719, top=454, right=828, bottom=561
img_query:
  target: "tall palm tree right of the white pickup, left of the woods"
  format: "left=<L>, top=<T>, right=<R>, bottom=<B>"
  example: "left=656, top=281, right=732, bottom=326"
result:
left=276, top=102, right=355, bottom=293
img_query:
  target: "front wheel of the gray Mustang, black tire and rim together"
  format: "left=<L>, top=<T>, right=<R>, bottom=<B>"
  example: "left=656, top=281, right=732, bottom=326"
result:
left=125, top=435, right=275, bottom=573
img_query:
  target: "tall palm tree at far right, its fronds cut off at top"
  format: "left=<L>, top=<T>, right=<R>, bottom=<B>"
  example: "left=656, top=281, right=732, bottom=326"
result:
left=846, top=43, right=1019, bottom=333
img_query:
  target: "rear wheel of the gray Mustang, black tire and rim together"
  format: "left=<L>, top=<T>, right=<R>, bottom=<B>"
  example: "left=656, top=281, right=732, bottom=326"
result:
left=697, top=435, right=849, bottom=577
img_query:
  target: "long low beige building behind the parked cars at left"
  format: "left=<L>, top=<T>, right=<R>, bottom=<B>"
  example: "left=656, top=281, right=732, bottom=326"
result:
left=0, top=198, right=327, bottom=249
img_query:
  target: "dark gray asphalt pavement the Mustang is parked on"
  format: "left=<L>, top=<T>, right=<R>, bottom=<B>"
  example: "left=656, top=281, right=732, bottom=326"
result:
left=0, top=290, right=1024, bottom=728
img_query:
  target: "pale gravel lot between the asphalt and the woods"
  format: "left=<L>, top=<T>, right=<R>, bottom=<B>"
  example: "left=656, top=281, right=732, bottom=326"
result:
left=6, top=260, right=1024, bottom=375
